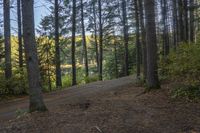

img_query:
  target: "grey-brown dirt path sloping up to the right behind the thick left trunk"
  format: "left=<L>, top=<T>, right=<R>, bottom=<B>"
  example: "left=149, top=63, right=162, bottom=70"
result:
left=0, top=77, right=134, bottom=122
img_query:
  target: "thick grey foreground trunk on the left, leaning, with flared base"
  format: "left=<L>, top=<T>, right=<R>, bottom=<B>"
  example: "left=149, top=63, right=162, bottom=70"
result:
left=22, top=0, right=47, bottom=112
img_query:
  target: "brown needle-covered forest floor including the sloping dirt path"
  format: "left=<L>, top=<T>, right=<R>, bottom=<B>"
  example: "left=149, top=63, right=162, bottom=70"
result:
left=0, top=77, right=200, bottom=133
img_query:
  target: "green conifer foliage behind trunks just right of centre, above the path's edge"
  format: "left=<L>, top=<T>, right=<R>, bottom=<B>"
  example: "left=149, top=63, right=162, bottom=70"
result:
left=103, top=35, right=136, bottom=79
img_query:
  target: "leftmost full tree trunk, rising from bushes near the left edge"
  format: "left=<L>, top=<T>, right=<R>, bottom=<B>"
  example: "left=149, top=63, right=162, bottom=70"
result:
left=3, top=0, right=12, bottom=79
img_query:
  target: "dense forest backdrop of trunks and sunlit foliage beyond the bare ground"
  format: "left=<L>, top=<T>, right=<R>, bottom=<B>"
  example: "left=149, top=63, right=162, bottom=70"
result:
left=0, top=0, right=200, bottom=107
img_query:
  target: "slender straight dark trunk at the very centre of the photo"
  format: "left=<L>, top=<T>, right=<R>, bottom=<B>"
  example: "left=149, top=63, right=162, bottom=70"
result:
left=98, top=0, right=103, bottom=80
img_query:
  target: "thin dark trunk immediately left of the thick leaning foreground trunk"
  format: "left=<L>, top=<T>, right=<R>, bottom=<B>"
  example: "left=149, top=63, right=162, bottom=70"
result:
left=17, top=0, right=23, bottom=68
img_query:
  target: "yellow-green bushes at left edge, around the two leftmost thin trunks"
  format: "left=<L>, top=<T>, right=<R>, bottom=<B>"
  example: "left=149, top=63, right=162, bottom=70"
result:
left=0, top=35, right=28, bottom=96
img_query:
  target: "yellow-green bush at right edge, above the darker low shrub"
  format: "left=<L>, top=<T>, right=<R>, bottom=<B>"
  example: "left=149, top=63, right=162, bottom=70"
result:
left=159, top=44, right=200, bottom=85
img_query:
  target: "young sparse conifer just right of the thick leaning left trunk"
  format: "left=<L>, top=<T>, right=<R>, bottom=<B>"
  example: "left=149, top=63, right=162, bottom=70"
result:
left=37, top=36, right=55, bottom=92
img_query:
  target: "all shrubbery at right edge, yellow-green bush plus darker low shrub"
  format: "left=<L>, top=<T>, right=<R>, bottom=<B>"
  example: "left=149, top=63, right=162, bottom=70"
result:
left=159, top=44, right=200, bottom=99
